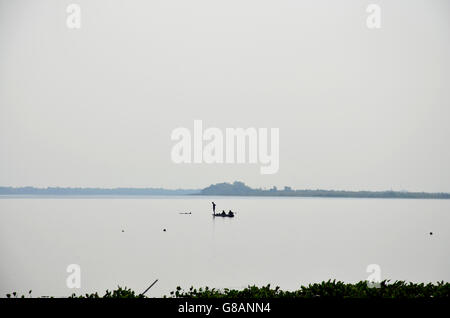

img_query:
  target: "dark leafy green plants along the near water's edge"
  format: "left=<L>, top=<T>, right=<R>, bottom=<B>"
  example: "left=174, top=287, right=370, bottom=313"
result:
left=7, top=280, right=450, bottom=299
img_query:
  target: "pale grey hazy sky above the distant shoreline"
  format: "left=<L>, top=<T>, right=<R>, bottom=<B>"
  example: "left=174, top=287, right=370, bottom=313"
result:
left=0, top=0, right=450, bottom=192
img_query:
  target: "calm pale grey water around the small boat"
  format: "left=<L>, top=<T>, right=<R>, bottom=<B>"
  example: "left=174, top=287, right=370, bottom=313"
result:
left=0, top=197, right=450, bottom=297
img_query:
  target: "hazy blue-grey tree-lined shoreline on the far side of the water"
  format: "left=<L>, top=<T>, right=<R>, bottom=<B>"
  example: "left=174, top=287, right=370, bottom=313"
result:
left=0, top=181, right=450, bottom=199
